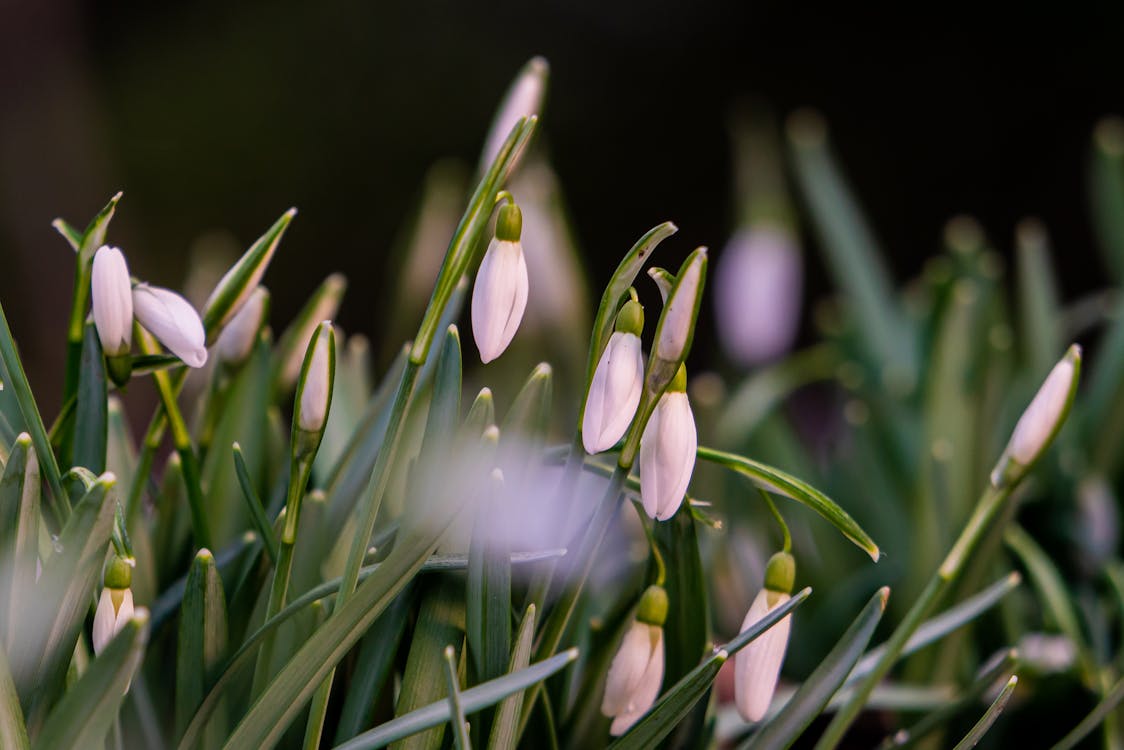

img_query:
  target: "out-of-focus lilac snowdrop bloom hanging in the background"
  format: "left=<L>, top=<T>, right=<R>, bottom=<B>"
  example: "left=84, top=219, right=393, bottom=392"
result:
left=715, top=226, right=803, bottom=365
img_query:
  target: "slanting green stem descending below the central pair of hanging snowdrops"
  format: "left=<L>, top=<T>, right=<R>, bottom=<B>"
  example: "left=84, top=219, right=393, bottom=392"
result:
left=516, top=463, right=631, bottom=737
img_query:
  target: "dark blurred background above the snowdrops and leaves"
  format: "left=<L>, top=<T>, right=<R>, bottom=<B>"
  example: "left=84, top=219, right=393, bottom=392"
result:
left=0, top=0, right=1124, bottom=413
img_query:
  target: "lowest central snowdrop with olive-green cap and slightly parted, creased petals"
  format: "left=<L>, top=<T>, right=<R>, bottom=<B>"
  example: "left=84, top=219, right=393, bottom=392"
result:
left=601, top=586, right=668, bottom=737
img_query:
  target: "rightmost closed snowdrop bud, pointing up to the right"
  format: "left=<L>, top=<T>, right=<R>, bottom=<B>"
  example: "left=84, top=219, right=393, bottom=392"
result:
left=991, top=344, right=1081, bottom=487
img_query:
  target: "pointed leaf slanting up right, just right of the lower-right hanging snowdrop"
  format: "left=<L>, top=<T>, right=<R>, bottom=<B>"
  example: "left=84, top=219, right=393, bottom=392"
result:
left=746, top=588, right=890, bottom=750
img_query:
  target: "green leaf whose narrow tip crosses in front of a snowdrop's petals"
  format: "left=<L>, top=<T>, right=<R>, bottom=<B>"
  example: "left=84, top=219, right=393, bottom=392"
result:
left=609, top=588, right=812, bottom=750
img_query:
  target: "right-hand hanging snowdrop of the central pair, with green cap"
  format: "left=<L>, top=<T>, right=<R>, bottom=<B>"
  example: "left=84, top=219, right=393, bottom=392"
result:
left=640, top=365, right=698, bottom=521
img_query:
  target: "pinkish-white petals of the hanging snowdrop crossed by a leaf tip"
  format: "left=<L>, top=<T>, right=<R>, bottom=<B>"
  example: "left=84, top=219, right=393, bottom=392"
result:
left=734, top=589, right=792, bottom=722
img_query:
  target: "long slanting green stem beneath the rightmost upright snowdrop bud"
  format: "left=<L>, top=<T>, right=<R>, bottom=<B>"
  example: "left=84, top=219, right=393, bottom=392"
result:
left=815, top=484, right=1014, bottom=750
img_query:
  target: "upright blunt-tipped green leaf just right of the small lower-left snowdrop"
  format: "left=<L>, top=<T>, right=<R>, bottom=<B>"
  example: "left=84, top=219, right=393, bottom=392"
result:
left=175, top=550, right=227, bottom=748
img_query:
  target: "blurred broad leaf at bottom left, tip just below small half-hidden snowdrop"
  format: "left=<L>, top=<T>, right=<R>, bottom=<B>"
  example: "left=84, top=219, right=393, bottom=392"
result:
left=33, top=611, right=148, bottom=750
